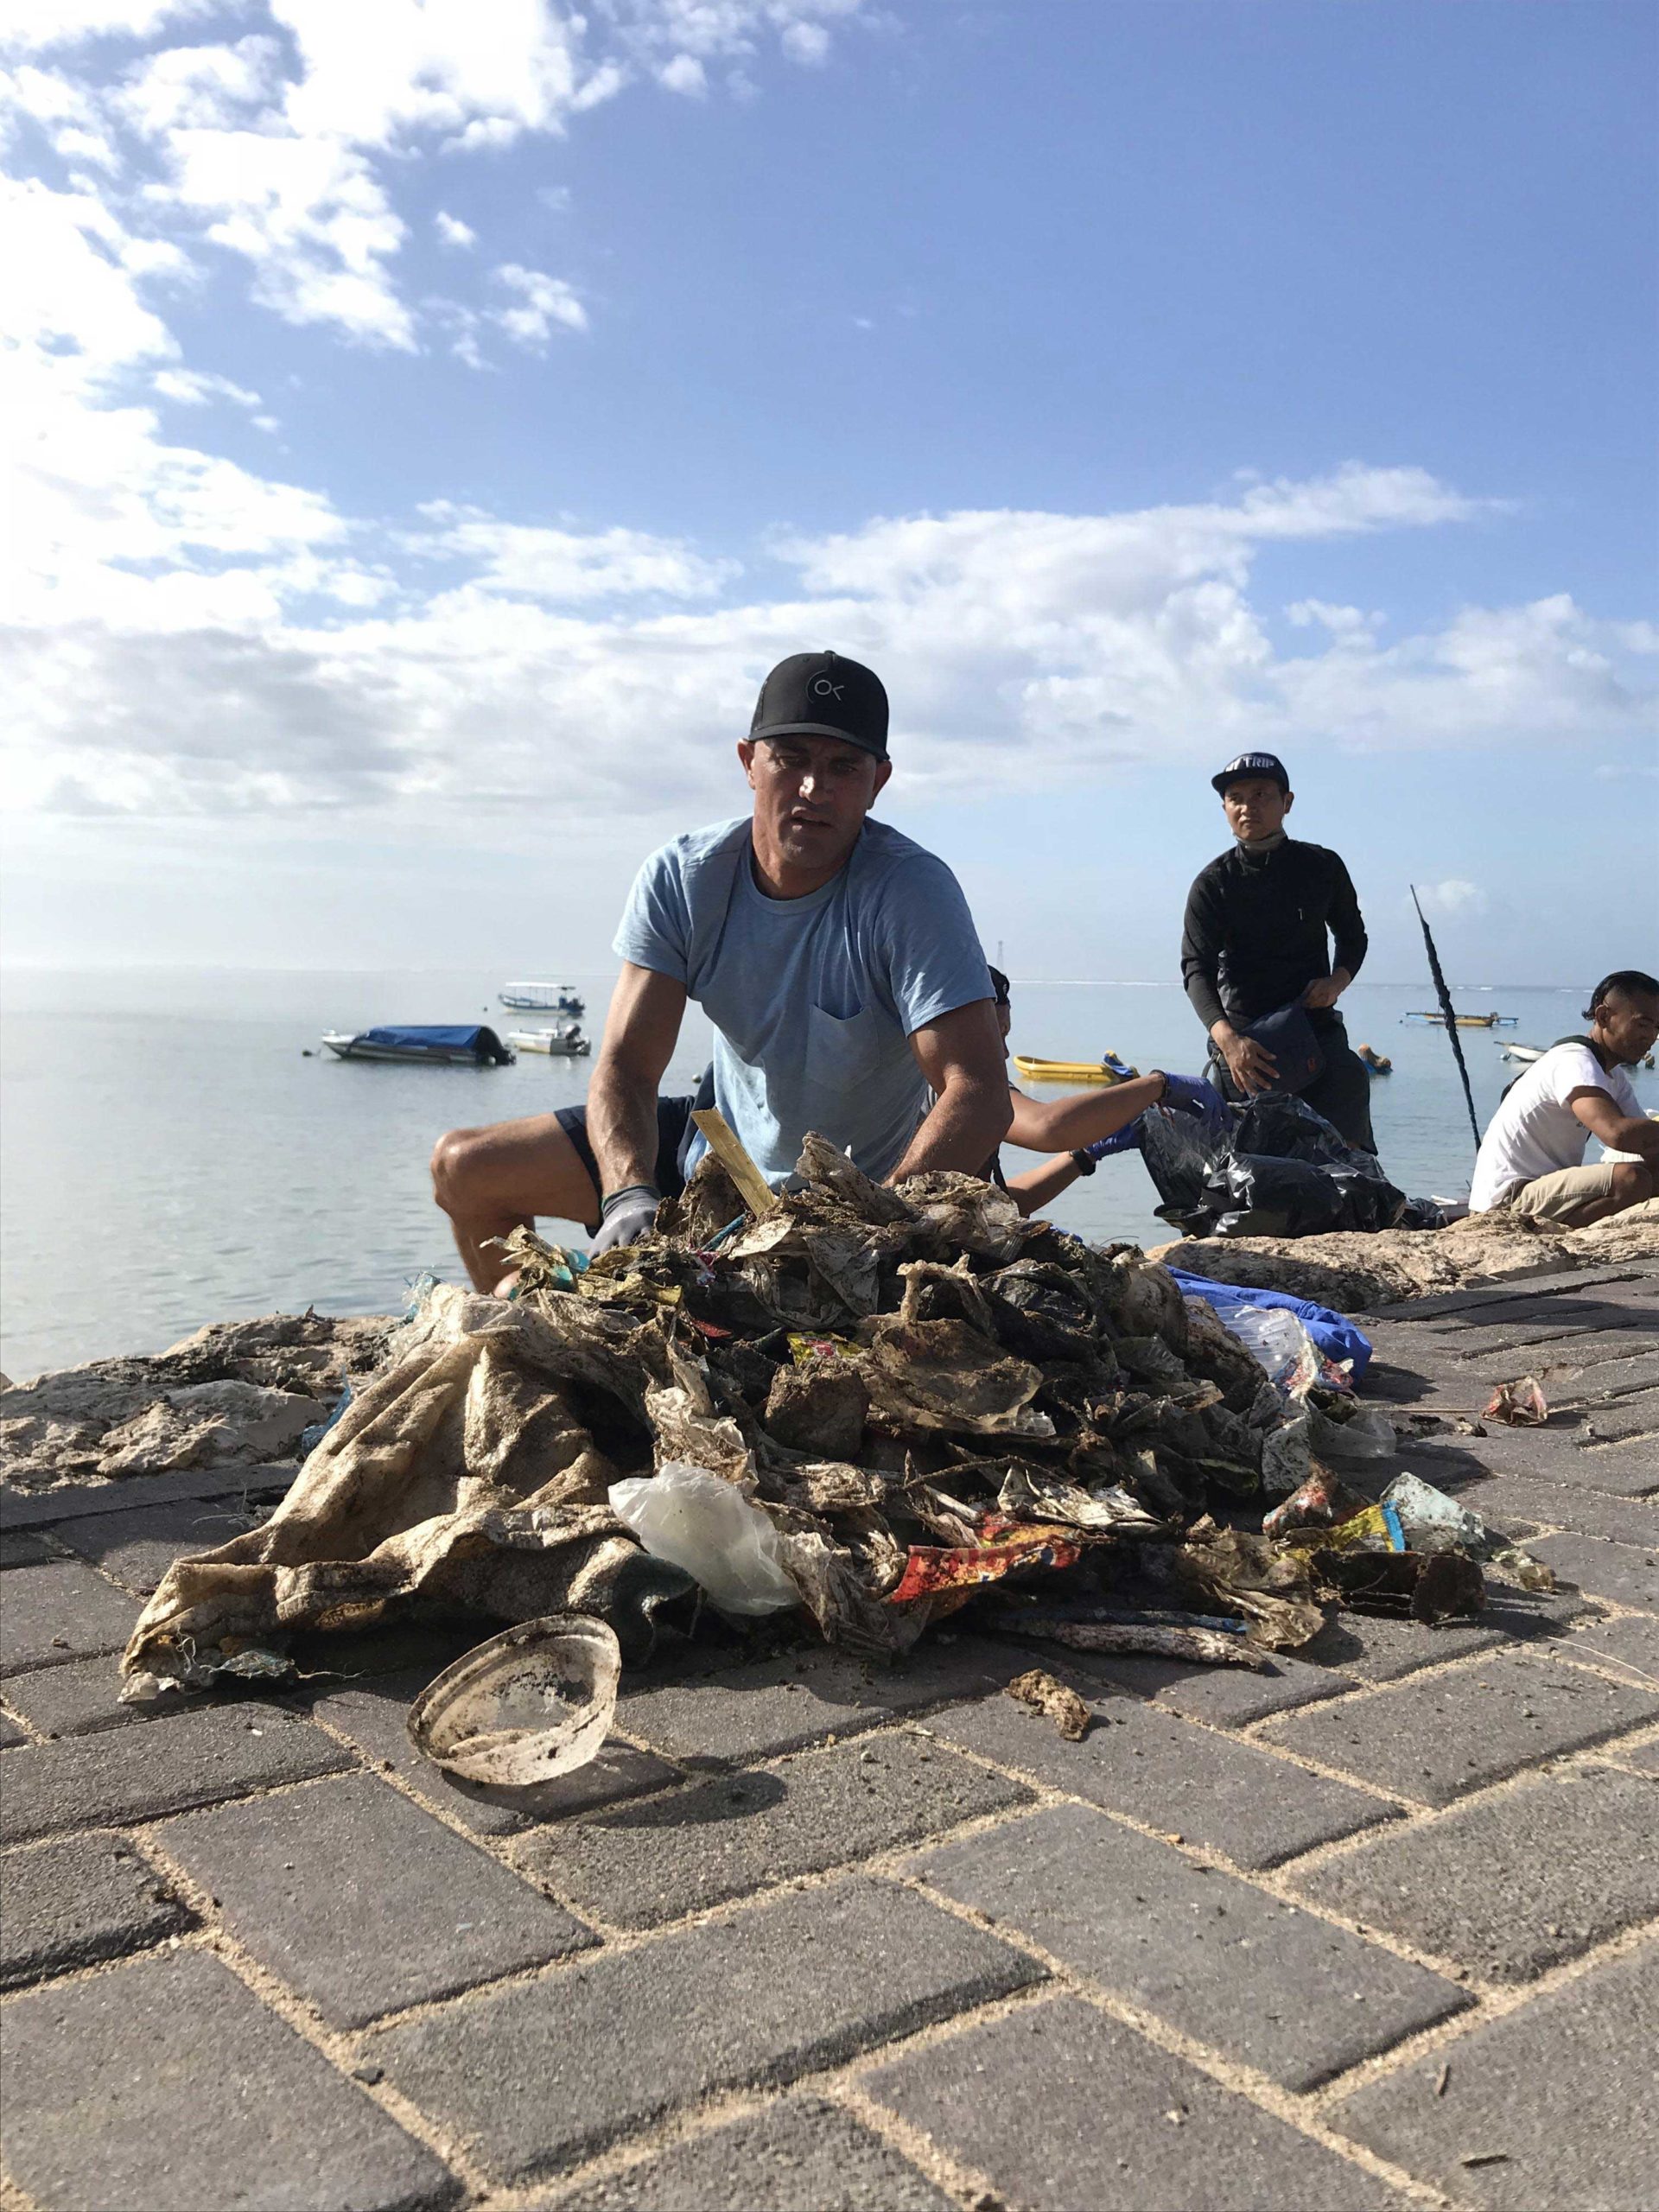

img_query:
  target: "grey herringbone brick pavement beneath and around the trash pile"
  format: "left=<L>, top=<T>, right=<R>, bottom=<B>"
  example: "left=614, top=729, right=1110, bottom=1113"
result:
left=0, top=1263, right=1659, bottom=2212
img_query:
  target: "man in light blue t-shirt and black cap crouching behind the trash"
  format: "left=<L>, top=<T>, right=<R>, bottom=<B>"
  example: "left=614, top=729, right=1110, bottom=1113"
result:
left=431, top=652, right=1013, bottom=1289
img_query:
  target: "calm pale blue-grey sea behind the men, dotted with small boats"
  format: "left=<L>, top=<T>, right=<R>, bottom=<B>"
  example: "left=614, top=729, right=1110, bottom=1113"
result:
left=0, top=964, right=1659, bottom=1380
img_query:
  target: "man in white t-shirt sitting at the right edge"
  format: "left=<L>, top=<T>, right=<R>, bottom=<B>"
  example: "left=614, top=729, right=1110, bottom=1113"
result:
left=1469, top=969, right=1659, bottom=1230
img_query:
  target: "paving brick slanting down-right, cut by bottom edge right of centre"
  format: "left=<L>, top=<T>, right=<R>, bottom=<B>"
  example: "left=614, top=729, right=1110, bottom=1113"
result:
left=862, top=1998, right=1398, bottom=2212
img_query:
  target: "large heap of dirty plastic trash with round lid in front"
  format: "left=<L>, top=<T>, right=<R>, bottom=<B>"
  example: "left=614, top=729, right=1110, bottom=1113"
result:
left=124, top=1123, right=1557, bottom=1778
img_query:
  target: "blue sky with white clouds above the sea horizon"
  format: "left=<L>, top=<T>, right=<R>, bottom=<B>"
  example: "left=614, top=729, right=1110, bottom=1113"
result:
left=0, top=0, right=1659, bottom=984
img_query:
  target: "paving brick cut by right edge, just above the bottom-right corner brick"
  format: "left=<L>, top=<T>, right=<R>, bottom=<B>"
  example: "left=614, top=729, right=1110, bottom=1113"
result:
left=1292, top=1767, right=1659, bottom=1982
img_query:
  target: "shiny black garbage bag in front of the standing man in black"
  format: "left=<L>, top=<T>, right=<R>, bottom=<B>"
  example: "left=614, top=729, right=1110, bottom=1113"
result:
left=1141, top=1097, right=1407, bottom=1236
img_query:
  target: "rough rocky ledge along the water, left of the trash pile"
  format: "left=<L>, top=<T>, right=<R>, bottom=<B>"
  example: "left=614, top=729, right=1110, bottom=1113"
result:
left=0, top=1314, right=394, bottom=1489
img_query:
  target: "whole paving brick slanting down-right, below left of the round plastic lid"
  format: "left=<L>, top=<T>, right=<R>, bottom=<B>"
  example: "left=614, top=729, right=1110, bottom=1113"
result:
left=162, top=1774, right=593, bottom=2029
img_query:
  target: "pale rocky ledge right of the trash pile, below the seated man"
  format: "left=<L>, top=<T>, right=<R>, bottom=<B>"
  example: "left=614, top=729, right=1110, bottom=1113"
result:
left=1148, top=1199, right=1659, bottom=1314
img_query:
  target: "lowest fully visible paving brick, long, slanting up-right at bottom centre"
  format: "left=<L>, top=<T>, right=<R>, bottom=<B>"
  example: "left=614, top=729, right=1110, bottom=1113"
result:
left=376, top=1876, right=1042, bottom=2181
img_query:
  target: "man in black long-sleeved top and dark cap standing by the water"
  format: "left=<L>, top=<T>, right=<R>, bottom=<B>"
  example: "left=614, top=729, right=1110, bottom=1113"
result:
left=1181, top=752, right=1376, bottom=1153
